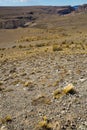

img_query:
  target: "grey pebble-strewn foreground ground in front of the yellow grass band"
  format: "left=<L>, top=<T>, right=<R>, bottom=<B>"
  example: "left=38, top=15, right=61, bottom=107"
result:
left=0, top=51, right=87, bottom=130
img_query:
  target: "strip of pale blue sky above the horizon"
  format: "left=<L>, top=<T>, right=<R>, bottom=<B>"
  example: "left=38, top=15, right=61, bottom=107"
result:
left=0, top=0, right=87, bottom=6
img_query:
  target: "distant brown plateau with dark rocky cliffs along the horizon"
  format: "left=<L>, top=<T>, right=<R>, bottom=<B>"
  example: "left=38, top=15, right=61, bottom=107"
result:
left=0, top=4, right=87, bottom=29
